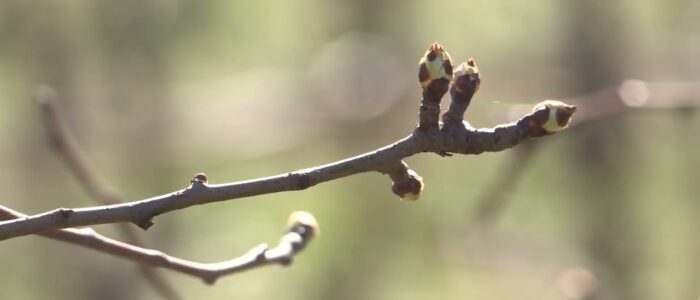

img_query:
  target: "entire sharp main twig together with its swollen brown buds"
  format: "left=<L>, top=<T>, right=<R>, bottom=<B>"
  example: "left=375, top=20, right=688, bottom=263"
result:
left=0, top=45, right=576, bottom=240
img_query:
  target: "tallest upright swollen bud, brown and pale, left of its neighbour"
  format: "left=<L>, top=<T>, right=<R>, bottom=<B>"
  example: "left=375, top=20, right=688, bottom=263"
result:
left=418, top=43, right=452, bottom=90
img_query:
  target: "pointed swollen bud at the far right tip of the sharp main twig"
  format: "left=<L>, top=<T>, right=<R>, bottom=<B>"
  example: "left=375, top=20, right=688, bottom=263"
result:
left=532, top=100, right=576, bottom=134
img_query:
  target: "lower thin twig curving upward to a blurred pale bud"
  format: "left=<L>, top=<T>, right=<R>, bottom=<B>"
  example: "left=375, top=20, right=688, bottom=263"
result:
left=0, top=205, right=318, bottom=284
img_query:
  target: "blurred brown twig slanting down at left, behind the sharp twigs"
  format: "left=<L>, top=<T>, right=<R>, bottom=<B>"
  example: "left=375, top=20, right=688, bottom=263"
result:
left=36, top=86, right=182, bottom=299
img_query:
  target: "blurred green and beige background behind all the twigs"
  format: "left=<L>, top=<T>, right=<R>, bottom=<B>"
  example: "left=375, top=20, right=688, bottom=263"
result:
left=0, top=0, right=700, bottom=299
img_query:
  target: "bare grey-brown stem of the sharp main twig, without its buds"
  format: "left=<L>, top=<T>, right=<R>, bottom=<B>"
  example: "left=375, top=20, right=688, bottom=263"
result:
left=0, top=108, right=568, bottom=240
